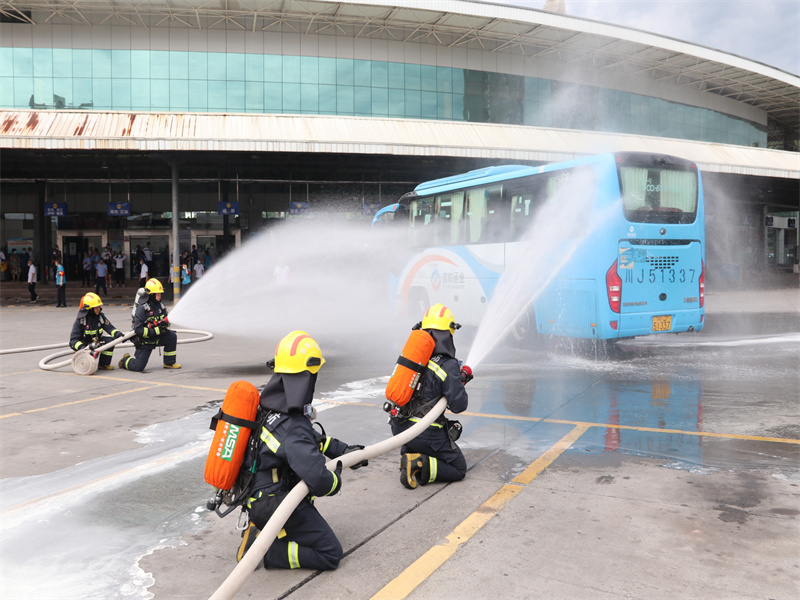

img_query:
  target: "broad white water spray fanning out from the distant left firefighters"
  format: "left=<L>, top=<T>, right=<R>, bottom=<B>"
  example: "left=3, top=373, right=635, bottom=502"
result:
left=170, top=219, right=409, bottom=344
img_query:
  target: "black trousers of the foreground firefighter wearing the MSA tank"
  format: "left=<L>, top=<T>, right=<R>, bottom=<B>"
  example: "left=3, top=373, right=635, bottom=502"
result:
left=250, top=496, right=344, bottom=571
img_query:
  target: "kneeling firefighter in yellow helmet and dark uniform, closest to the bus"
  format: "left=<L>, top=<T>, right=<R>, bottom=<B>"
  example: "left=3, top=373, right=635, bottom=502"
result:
left=390, top=304, right=472, bottom=489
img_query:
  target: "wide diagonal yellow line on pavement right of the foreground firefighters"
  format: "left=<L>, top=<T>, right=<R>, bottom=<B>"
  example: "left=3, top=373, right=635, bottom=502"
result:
left=370, top=426, right=589, bottom=600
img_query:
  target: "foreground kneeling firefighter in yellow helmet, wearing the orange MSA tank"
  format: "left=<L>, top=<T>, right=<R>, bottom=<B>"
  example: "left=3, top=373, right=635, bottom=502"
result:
left=238, top=331, right=366, bottom=570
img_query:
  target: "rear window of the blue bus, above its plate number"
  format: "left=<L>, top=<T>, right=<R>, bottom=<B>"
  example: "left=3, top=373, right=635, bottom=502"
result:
left=619, top=166, right=697, bottom=223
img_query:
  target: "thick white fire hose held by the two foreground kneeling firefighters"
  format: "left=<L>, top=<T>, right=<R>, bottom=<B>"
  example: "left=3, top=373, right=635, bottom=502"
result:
left=210, top=396, right=447, bottom=600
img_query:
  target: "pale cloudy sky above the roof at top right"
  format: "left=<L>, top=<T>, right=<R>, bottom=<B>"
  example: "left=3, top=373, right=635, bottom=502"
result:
left=496, top=0, right=800, bottom=75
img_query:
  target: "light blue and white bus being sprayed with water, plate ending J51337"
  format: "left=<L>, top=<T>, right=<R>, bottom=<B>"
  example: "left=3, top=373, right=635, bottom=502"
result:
left=373, top=152, right=705, bottom=340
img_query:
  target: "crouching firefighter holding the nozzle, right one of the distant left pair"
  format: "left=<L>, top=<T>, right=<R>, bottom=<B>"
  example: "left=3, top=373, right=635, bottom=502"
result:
left=119, top=279, right=181, bottom=371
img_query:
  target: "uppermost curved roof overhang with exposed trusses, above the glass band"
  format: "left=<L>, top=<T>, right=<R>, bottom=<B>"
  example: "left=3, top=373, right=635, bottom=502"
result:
left=0, top=0, right=800, bottom=132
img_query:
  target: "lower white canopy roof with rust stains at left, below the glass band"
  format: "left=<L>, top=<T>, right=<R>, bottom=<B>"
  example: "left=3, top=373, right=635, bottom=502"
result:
left=0, top=110, right=800, bottom=180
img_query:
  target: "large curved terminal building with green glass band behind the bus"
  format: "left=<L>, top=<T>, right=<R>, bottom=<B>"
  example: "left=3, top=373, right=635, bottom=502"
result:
left=0, top=0, right=800, bottom=285
